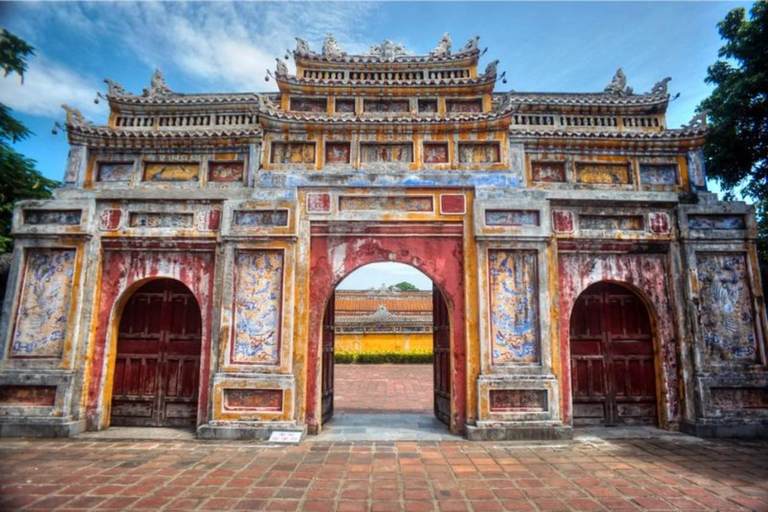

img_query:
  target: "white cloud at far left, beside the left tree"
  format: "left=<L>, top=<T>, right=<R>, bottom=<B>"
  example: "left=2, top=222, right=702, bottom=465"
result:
left=0, top=57, right=103, bottom=118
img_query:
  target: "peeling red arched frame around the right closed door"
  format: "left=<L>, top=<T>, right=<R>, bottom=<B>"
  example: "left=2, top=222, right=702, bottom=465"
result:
left=558, top=251, right=682, bottom=428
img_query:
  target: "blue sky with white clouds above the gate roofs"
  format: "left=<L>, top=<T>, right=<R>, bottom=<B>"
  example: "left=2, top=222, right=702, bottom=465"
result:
left=0, top=2, right=750, bottom=285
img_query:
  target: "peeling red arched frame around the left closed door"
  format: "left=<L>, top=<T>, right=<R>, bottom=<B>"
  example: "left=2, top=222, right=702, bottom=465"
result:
left=85, top=247, right=215, bottom=430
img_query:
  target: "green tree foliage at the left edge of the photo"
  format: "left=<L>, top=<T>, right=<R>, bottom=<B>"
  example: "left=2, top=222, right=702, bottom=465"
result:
left=0, top=29, right=59, bottom=253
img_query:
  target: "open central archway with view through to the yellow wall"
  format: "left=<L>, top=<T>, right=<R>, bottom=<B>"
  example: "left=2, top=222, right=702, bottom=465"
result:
left=321, top=263, right=451, bottom=427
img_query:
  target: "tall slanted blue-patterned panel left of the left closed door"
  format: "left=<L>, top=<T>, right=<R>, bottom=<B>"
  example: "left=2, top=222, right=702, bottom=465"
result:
left=11, top=249, right=75, bottom=358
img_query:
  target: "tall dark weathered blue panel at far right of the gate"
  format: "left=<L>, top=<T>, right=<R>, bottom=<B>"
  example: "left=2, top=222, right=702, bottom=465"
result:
left=696, top=253, right=757, bottom=363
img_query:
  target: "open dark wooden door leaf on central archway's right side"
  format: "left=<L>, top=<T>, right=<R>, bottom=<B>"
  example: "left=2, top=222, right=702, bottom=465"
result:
left=432, top=288, right=451, bottom=425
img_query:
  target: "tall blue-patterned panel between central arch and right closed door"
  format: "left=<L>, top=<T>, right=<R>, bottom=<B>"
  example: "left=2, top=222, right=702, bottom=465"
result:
left=488, top=250, right=539, bottom=365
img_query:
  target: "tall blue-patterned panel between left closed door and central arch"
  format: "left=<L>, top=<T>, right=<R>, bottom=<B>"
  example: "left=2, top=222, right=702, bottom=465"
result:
left=231, top=250, right=283, bottom=364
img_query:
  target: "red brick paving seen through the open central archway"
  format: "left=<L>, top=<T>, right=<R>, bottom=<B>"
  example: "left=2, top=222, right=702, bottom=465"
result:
left=333, top=364, right=434, bottom=414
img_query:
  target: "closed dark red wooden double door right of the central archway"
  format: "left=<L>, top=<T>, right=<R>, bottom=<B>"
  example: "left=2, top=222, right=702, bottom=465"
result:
left=571, top=283, right=657, bottom=426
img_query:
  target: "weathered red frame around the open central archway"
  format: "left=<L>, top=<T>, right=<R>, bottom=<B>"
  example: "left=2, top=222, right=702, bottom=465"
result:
left=306, top=223, right=467, bottom=434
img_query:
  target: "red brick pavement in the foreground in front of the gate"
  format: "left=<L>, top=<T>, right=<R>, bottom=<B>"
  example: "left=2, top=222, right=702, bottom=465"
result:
left=0, top=436, right=768, bottom=512
